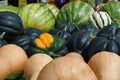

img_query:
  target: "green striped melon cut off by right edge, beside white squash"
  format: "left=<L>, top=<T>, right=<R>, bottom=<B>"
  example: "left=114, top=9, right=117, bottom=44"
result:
left=101, top=1, right=120, bottom=25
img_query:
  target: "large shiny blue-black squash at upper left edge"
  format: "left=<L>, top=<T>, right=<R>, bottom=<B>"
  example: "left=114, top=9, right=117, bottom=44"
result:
left=0, top=11, right=23, bottom=42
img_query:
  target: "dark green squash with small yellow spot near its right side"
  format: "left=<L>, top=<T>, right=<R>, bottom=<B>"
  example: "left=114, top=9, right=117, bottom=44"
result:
left=67, top=24, right=98, bottom=54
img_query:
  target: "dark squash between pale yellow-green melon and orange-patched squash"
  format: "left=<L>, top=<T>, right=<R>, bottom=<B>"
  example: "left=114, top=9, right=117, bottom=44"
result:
left=23, top=28, right=42, bottom=39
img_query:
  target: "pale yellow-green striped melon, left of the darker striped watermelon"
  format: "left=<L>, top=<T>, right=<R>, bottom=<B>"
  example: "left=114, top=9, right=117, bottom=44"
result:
left=19, top=3, right=55, bottom=32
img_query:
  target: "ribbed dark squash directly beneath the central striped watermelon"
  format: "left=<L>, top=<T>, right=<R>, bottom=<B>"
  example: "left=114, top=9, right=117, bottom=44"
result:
left=49, top=23, right=79, bottom=40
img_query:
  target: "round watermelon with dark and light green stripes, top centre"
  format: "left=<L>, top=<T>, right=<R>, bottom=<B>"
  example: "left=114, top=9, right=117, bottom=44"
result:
left=56, top=1, right=94, bottom=26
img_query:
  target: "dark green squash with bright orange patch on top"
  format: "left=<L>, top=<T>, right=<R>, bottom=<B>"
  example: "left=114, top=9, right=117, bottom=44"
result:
left=29, top=33, right=68, bottom=57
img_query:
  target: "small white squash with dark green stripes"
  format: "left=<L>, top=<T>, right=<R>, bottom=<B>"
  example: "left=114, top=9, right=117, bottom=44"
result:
left=89, top=11, right=111, bottom=29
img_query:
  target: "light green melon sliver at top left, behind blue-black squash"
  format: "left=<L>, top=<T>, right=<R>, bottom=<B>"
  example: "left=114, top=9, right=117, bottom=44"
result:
left=0, top=6, right=19, bottom=14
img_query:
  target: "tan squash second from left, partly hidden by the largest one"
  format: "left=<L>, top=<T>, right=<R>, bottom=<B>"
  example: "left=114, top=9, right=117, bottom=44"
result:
left=24, top=53, right=53, bottom=80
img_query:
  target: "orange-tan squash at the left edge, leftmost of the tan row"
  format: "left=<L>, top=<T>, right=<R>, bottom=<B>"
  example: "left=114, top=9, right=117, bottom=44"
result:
left=0, top=44, right=28, bottom=79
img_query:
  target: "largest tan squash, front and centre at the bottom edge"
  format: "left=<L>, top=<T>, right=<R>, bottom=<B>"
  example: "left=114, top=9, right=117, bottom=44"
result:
left=37, top=56, right=97, bottom=80
